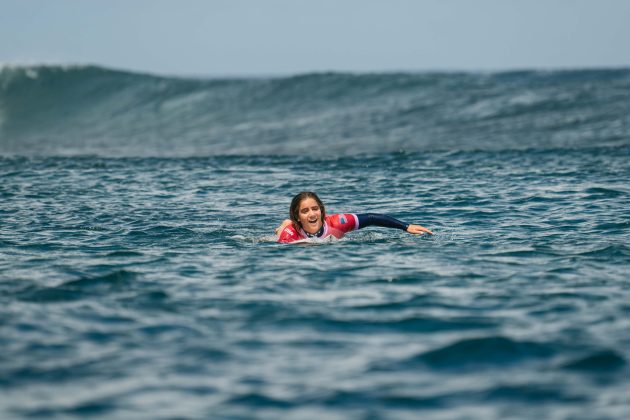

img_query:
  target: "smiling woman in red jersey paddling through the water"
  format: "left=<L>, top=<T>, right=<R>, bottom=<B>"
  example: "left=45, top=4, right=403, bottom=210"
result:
left=276, top=191, right=433, bottom=242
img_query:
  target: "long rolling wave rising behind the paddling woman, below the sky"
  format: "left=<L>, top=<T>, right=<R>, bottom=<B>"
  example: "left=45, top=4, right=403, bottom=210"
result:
left=0, top=66, right=630, bottom=157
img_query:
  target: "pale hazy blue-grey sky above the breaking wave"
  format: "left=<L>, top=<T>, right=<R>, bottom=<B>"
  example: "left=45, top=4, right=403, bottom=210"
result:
left=0, top=0, right=630, bottom=75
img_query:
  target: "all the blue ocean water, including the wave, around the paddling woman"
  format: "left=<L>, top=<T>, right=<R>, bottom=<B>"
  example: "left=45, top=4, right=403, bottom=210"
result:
left=0, top=66, right=630, bottom=419
